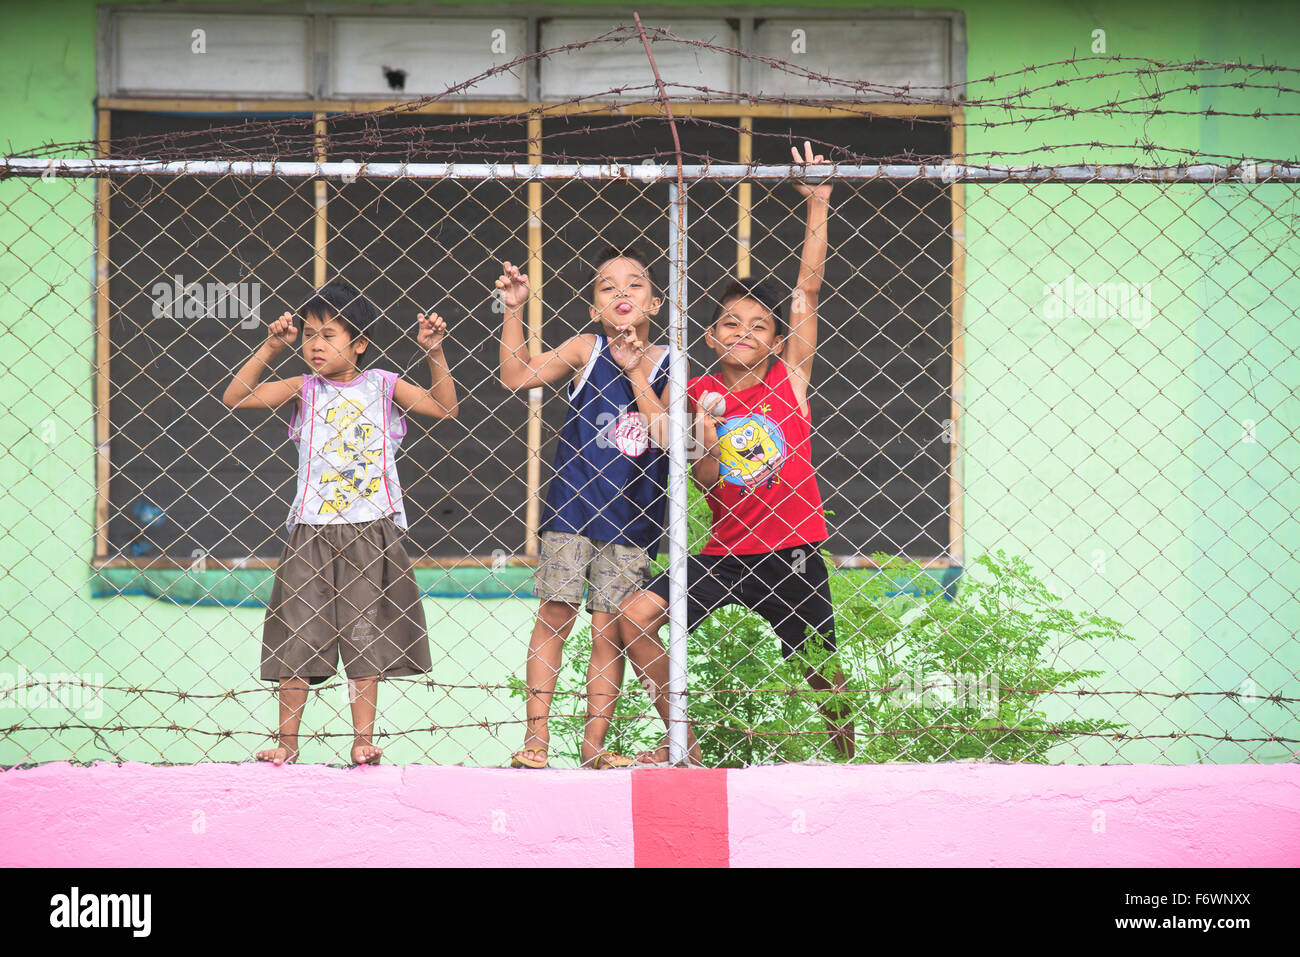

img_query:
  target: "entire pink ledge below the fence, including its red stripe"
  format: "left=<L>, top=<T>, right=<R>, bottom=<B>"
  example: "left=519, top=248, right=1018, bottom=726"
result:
left=0, top=763, right=1300, bottom=867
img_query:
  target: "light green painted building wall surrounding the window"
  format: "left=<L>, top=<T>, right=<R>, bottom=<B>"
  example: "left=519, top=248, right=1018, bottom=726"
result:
left=0, top=0, right=1300, bottom=765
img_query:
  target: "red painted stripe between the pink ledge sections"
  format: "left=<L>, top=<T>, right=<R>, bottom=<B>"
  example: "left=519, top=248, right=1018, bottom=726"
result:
left=632, top=767, right=731, bottom=867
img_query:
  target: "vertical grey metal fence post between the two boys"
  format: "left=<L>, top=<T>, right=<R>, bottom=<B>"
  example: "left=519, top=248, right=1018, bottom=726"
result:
left=668, top=183, right=688, bottom=765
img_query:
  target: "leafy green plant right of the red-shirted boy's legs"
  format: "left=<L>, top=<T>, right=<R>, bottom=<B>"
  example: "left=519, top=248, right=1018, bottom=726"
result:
left=810, top=550, right=1132, bottom=763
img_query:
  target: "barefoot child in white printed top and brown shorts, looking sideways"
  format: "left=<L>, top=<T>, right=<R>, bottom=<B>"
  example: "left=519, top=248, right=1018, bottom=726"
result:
left=222, top=283, right=456, bottom=765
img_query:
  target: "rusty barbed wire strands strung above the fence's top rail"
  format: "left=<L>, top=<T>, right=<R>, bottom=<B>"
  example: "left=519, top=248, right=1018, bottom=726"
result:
left=5, top=25, right=1300, bottom=163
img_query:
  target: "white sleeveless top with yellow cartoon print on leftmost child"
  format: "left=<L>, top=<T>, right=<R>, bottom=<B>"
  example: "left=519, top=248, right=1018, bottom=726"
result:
left=285, top=369, right=407, bottom=528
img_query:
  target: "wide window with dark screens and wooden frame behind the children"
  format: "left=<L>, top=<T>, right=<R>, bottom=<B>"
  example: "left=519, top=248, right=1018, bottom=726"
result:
left=96, top=9, right=961, bottom=564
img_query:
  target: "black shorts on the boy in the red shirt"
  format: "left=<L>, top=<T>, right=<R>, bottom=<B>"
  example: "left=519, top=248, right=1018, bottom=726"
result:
left=646, top=545, right=836, bottom=658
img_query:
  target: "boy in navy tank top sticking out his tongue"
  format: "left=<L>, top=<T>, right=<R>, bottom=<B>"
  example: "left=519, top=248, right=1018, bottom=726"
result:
left=497, top=247, right=668, bottom=770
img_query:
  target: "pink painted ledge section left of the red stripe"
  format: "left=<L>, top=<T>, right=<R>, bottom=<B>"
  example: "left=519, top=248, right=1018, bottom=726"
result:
left=0, top=763, right=632, bottom=867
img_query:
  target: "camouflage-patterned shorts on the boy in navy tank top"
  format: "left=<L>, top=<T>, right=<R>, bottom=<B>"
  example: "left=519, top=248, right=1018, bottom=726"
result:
left=533, top=532, right=650, bottom=614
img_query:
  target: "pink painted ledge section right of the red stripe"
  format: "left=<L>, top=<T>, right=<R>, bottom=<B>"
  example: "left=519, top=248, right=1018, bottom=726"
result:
left=727, top=763, right=1300, bottom=867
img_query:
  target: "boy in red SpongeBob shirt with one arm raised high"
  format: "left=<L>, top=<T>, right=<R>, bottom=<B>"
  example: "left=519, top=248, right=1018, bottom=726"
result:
left=621, top=143, right=854, bottom=763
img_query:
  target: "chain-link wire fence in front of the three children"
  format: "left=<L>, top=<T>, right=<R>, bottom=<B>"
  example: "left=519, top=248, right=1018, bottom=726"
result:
left=0, top=33, right=1300, bottom=766
